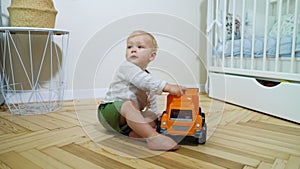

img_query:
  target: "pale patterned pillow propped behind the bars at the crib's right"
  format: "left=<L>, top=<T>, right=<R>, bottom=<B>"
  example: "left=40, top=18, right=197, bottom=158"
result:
left=269, top=14, right=300, bottom=37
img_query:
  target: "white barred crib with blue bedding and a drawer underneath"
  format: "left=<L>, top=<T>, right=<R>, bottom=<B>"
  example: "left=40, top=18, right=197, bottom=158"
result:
left=207, top=0, right=300, bottom=123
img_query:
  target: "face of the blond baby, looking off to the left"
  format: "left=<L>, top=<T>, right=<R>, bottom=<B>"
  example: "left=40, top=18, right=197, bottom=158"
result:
left=126, top=35, right=156, bottom=70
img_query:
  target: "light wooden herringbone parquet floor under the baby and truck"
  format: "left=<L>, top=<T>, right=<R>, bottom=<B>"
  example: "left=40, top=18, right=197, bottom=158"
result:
left=0, top=95, right=300, bottom=169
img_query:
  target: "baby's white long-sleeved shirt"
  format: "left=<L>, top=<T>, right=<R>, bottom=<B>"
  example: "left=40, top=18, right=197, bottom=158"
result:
left=102, top=61, right=166, bottom=115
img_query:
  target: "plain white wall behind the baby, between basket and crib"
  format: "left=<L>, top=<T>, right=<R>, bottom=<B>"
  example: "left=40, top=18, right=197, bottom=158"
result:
left=2, top=0, right=205, bottom=97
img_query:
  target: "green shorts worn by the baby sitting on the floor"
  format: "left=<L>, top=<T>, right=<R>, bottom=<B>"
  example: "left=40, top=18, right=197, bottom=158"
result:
left=98, top=101, right=132, bottom=135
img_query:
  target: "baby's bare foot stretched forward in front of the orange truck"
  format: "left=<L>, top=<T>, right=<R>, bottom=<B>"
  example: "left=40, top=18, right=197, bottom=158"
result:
left=146, top=134, right=180, bottom=151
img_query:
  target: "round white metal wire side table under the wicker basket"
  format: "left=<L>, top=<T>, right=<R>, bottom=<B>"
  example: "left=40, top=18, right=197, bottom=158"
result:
left=0, top=27, right=69, bottom=115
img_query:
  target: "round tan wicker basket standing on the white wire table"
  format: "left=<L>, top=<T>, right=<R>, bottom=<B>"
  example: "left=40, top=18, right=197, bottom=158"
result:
left=7, top=0, right=57, bottom=28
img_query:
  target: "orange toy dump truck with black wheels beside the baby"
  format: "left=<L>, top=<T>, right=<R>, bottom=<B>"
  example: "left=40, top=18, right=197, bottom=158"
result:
left=157, top=88, right=206, bottom=144
